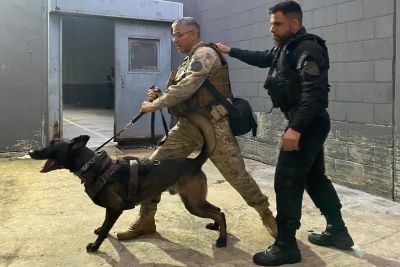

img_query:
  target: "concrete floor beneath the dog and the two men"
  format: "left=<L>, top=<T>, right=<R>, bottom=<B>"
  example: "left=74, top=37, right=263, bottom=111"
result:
left=0, top=108, right=400, bottom=267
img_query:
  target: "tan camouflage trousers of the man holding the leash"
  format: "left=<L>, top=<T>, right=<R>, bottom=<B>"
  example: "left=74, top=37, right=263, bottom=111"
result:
left=140, top=117, right=269, bottom=216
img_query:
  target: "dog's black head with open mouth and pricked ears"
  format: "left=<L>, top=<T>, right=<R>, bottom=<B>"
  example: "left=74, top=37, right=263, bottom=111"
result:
left=29, top=135, right=90, bottom=172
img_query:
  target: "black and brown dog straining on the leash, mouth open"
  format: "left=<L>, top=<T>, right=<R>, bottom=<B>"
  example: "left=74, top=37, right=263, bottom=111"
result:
left=29, top=115, right=227, bottom=252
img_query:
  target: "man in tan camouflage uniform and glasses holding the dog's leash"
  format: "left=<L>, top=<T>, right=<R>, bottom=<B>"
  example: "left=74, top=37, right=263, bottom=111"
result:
left=117, top=17, right=277, bottom=240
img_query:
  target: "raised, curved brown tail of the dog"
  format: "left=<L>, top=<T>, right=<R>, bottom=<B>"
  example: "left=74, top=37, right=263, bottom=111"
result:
left=189, top=113, right=216, bottom=166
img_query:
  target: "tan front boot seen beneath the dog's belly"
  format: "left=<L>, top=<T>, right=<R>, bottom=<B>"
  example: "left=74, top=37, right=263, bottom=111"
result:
left=117, top=203, right=157, bottom=240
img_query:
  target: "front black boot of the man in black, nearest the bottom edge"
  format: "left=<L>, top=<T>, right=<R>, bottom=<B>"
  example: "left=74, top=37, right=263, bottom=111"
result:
left=253, top=241, right=301, bottom=266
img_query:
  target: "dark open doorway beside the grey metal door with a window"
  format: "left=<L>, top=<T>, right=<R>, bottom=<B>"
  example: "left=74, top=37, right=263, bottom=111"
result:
left=62, top=17, right=115, bottom=148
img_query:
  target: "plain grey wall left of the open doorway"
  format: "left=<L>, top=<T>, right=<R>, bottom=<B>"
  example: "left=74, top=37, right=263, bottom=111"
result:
left=0, top=0, right=47, bottom=152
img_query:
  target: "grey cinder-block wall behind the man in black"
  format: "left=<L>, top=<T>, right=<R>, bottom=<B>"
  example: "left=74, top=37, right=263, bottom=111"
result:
left=199, top=0, right=400, bottom=201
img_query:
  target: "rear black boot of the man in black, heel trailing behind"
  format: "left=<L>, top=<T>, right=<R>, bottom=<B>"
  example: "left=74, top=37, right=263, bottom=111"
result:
left=308, top=224, right=354, bottom=250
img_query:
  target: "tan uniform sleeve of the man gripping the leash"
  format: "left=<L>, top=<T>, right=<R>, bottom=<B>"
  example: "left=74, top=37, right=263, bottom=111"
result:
left=153, top=43, right=221, bottom=108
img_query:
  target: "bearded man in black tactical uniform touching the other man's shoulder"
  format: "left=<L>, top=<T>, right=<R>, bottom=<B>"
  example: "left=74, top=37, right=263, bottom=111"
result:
left=217, top=1, right=354, bottom=266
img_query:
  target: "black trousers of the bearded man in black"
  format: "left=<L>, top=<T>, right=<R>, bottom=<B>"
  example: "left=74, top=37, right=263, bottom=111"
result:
left=275, top=113, right=341, bottom=242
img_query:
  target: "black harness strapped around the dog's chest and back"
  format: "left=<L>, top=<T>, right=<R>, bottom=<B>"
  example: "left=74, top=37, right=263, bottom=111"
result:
left=75, top=151, right=159, bottom=209
